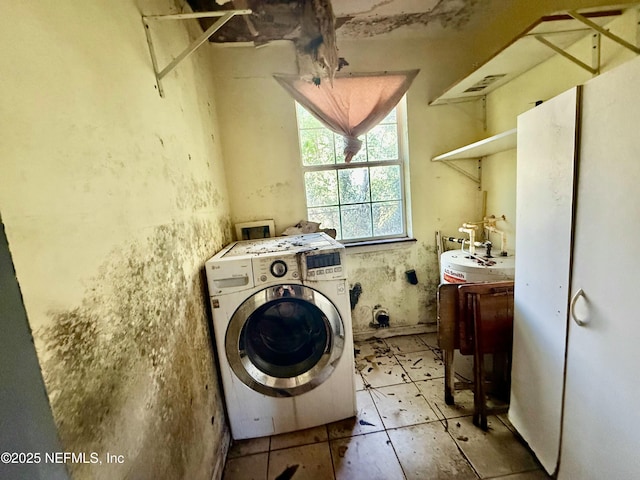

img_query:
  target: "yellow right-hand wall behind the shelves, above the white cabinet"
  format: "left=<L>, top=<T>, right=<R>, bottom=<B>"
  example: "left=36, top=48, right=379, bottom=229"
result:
left=482, top=8, right=639, bottom=248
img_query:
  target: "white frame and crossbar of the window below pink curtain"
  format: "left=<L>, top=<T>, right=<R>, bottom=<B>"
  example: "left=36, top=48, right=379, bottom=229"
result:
left=297, top=97, right=410, bottom=244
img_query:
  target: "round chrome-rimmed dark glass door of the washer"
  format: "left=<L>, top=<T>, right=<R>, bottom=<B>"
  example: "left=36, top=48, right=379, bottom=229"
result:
left=225, top=285, right=345, bottom=397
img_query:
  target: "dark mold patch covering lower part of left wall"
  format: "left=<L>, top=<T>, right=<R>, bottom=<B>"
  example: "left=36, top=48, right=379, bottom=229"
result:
left=35, top=218, right=231, bottom=479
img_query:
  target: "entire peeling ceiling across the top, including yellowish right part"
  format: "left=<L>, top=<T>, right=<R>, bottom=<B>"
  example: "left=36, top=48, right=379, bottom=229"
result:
left=187, top=0, right=636, bottom=82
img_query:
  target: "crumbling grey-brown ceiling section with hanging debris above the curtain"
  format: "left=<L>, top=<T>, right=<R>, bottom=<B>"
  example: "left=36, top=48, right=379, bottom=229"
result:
left=188, top=0, right=488, bottom=78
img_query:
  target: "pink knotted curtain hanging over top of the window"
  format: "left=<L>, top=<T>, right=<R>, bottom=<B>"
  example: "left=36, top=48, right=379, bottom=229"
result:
left=274, top=70, right=419, bottom=163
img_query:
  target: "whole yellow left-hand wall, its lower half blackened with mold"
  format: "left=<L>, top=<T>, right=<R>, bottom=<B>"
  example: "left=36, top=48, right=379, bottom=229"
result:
left=0, top=0, right=231, bottom=480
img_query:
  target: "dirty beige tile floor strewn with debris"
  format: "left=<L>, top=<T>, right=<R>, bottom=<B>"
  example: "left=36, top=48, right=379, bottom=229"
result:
left=223, top=333, right=551, bottom=480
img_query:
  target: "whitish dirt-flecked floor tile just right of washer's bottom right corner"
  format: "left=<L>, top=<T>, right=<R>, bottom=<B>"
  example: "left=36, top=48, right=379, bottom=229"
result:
left=371, top=383, right=437, bottom=428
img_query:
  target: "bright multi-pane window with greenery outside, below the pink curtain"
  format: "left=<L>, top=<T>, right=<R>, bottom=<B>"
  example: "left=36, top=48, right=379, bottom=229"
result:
left=296, top=104, right=407, bottom=242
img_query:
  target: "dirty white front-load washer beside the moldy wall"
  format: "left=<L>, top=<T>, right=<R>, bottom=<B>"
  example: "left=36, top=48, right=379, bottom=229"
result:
left=205, top=233, right=356, bottom=440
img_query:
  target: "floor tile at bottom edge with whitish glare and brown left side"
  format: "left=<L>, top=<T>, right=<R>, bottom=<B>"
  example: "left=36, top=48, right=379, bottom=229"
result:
left=331, top=432, right=405, bottom=480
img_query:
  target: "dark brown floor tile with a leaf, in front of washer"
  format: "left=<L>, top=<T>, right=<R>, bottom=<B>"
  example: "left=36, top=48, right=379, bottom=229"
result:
left=268, top=442, right=334, bottom=480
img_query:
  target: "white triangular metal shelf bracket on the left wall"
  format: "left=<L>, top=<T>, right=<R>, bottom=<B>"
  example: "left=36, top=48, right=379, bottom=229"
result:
left=142, top=9, right=251, bottom=97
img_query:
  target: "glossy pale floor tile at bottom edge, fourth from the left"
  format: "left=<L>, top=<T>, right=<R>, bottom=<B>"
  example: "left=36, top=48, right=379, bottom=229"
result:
left=387, top=422, right=478, bottom=480
